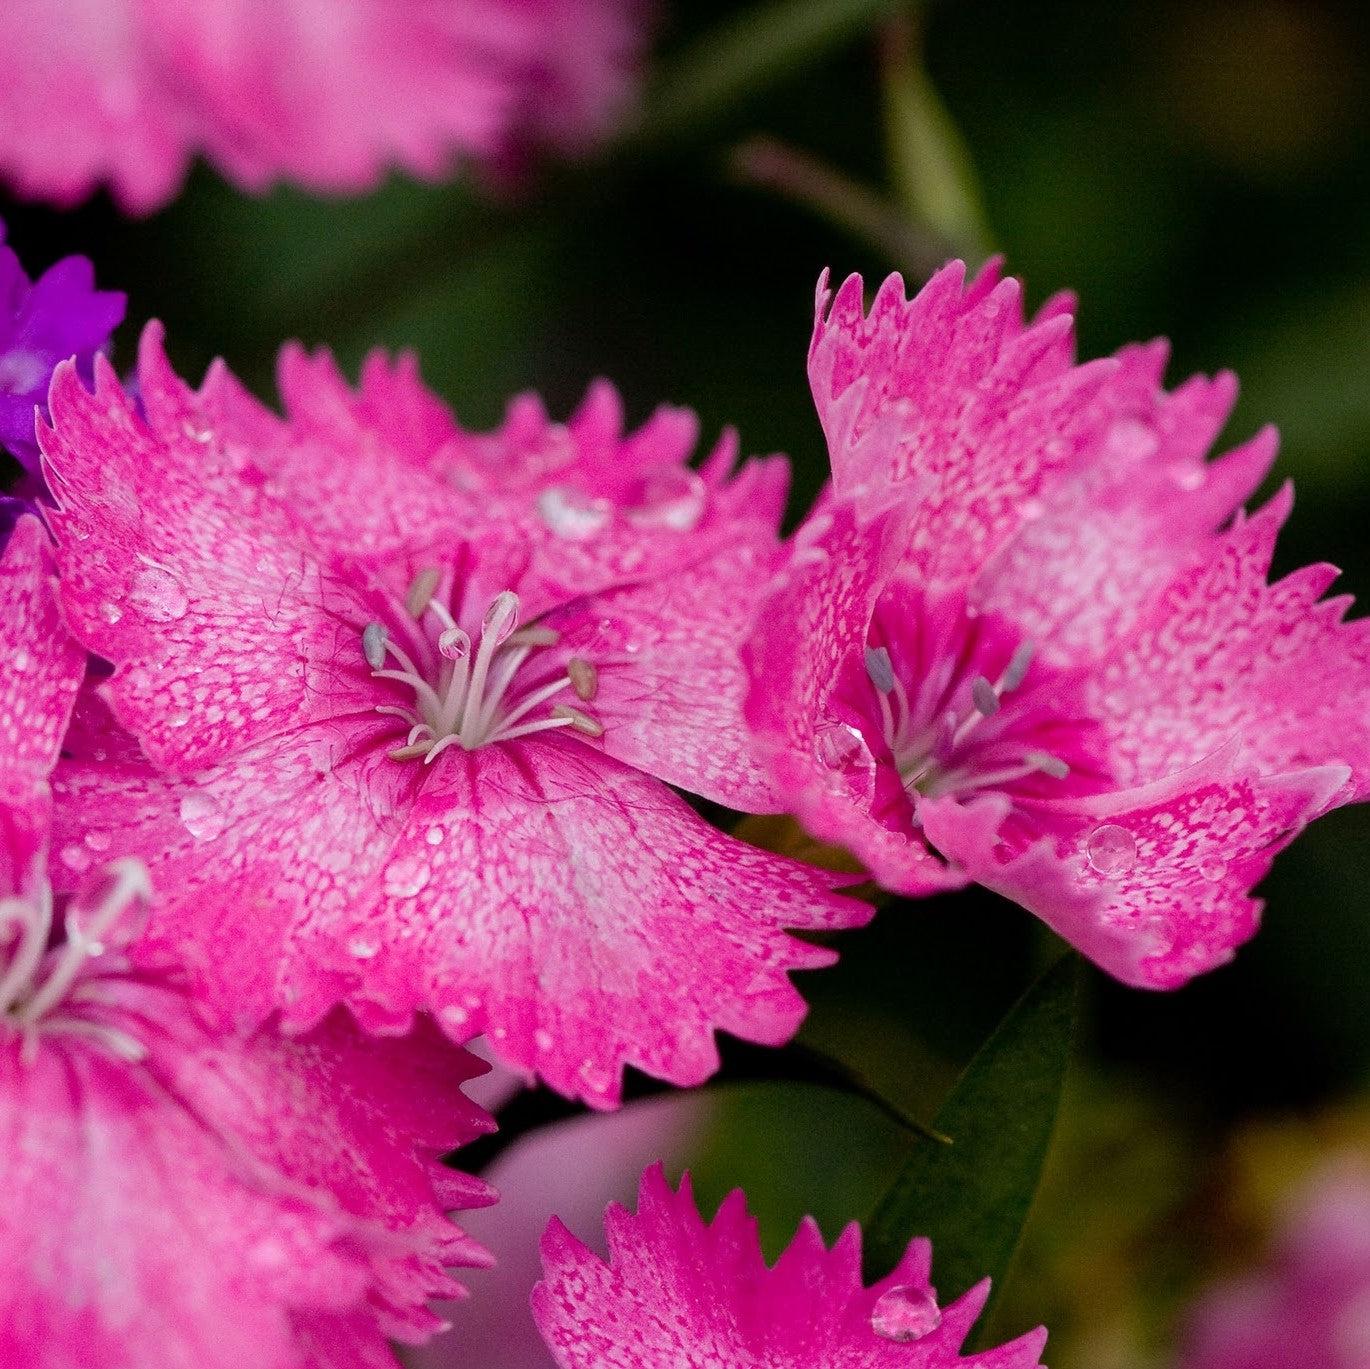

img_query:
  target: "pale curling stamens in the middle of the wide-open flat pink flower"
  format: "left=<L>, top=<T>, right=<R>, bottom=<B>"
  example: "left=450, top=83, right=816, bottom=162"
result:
left=362, top=569, right=604, bottom=765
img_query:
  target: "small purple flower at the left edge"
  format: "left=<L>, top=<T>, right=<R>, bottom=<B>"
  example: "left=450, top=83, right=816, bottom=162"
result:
left=0, top=225, right=125, bottom=530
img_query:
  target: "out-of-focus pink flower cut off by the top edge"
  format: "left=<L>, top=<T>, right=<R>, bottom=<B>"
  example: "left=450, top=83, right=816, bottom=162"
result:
left=0, top=0, right=644, bottom=214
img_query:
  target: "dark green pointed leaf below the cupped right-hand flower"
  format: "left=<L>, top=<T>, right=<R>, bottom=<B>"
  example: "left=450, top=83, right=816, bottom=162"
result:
left=866, top=952, right=1080, bottom=1300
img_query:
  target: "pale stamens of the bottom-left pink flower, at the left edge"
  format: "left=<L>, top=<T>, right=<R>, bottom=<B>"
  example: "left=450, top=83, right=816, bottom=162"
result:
left=0, top=859, right=152, bottom=1061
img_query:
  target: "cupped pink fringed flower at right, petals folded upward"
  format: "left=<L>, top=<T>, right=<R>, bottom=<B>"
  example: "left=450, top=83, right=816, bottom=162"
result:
left=747, top=263, right=1370, bottom=988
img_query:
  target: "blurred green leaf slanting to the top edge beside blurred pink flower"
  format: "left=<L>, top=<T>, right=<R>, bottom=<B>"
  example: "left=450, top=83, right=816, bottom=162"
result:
left=638, top=0, right=908, bottom=141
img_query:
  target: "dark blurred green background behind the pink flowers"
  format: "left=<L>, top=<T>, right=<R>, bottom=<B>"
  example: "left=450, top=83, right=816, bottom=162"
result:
left=10, top=0, right=1370, bottom=1369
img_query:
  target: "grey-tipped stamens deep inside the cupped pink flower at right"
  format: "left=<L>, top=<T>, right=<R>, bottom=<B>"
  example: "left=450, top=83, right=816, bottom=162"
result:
left=866, top=641, right=1070, bottom=799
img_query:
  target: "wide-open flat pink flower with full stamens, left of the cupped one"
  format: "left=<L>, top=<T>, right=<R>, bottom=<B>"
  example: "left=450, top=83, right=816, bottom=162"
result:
left=44, top=332, right=869, bottom=1106
